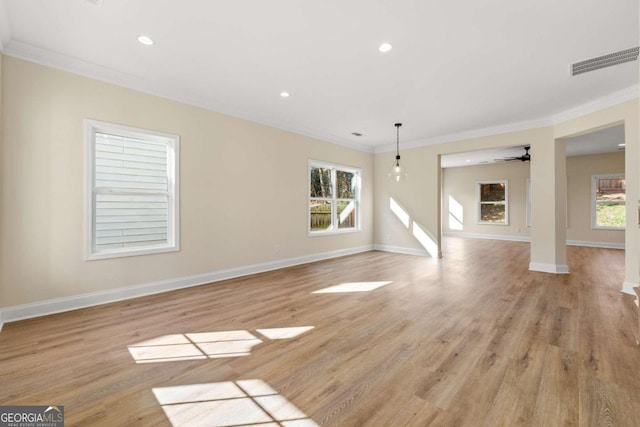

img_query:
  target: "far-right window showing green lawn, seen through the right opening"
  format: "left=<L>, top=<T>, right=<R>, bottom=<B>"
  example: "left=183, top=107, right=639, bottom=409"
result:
left=591, top=174, right=626, bottom=230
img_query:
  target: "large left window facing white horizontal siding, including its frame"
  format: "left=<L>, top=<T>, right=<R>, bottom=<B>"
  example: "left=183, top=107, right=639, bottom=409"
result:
left=85, top=120, right=179, bottom=260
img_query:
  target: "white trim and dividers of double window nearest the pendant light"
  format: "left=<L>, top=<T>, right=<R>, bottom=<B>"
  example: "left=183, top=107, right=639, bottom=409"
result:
left=307, top=159, right=362, bottom=237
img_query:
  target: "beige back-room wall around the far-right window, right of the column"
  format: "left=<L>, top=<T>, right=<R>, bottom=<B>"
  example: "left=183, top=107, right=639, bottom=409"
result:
left=567, top=152, right=634, bottom=243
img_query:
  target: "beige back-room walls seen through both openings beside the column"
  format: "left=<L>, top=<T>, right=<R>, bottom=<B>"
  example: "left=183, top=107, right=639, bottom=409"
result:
left=443, top=152, right=625, bottom=244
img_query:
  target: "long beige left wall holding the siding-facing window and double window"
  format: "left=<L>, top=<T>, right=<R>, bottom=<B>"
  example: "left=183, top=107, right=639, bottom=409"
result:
left=0, top=56, right=373, bottom=307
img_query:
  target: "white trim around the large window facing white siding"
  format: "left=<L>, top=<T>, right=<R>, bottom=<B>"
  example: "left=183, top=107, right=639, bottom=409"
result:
left=84, top=119, right=180, bottom=261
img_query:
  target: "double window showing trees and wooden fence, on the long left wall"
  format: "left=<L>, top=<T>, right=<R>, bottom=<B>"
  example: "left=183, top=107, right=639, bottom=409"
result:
left=309, top=161, right=360, bottom=235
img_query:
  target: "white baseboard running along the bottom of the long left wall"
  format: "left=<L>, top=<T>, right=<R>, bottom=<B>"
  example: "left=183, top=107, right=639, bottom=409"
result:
left=0, top=245, right=374, bottom=331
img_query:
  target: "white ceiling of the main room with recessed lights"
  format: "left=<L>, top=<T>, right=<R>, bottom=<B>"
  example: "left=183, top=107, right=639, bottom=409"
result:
left=0, top=0, right=639, bottom=151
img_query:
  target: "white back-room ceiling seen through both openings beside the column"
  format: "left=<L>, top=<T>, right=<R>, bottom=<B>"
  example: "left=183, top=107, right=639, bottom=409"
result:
left=441, top=125, right=625, bottom=168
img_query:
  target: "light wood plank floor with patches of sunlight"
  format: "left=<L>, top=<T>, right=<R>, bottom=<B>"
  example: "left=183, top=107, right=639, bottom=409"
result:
left=0, top=238, right=640, bottom=427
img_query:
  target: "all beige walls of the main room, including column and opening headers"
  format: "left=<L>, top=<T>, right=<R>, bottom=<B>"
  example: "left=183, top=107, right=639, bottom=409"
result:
left=0, top=56, right=640, bottom=307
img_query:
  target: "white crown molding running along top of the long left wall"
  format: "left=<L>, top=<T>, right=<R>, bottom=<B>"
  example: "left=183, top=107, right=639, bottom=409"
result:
left=0, top=39, right=373, bottom=153
